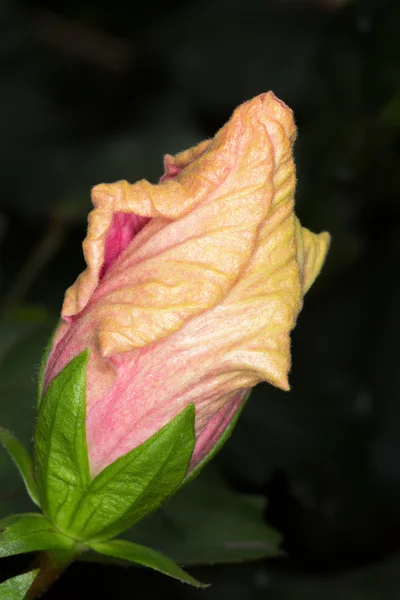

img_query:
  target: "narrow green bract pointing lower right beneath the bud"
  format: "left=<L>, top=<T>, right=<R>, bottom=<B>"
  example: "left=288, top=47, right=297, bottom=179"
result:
left=90, top=540, right=208, bottom=588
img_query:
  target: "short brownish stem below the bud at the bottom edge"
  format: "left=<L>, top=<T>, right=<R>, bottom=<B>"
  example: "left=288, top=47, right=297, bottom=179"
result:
left=25, top=549, right=80, bottom=600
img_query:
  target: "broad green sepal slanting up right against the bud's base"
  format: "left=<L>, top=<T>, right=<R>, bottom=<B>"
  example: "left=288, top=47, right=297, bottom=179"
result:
left=68, top=405, right=195, bottom=541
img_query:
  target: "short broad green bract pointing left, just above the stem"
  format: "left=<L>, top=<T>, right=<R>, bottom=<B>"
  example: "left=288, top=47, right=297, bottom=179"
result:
left=0, top=513, right=75, bottom=558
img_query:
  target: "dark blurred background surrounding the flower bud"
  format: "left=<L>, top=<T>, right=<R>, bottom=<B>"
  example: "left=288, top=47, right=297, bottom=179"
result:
left=0, top=0, right=400, bottom=600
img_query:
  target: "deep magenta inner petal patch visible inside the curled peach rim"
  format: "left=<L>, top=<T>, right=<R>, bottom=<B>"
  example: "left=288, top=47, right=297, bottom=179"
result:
left=100, top=212, right=150, bottom=279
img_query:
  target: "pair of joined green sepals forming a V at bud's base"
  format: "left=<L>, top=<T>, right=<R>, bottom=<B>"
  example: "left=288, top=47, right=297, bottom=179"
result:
left=35, top=351, right=195, bottom=541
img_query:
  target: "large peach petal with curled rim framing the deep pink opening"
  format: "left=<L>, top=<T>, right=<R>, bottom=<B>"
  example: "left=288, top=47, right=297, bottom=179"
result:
left=63, top=93, right=295, bottom=356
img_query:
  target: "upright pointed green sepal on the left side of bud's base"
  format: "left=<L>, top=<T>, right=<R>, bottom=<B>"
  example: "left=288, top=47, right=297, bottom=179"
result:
left=35, top=351, right=90, bottom=531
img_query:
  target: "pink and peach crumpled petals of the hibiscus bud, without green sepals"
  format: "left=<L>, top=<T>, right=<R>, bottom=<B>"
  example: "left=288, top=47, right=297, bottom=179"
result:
left=44, top=92, right=329, bottom=476
